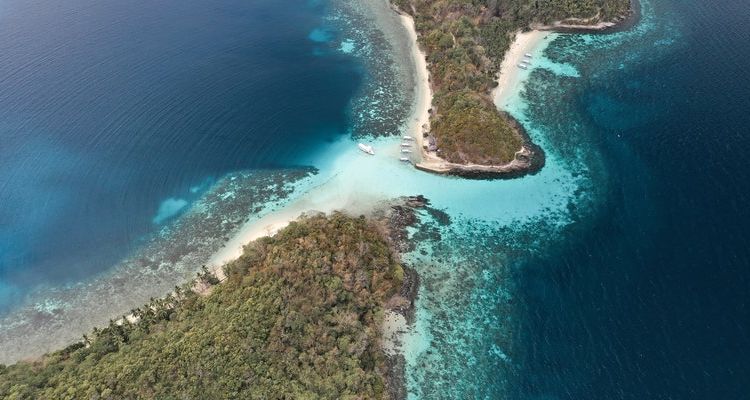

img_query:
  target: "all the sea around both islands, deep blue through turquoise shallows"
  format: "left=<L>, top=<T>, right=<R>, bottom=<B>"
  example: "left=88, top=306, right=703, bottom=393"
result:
left=0, top=0, right=750, bottom=399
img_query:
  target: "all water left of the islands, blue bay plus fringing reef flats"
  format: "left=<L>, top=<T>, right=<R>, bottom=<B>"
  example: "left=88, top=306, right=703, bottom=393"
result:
left=0, top=0, right=418, bottom=362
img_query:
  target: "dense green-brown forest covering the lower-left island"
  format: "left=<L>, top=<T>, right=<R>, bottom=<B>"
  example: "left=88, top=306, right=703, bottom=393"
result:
left=0, top=214, right=403, bottom=400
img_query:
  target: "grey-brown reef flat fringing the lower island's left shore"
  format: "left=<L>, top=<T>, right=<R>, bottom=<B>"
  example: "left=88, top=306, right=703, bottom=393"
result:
left=0, top=167, right=314, bottom=364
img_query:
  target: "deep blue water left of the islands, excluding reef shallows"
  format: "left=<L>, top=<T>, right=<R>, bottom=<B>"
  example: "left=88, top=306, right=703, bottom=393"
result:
left=0, top=0, right=362, bottom=313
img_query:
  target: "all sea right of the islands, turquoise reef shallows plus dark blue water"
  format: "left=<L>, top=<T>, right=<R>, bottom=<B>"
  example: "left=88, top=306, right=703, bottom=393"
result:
left=400, top=0, right=750, bottom=399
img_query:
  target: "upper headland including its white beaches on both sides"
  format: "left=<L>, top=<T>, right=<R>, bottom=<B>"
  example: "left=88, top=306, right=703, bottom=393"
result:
left=393, top=0, right=633, bottom=179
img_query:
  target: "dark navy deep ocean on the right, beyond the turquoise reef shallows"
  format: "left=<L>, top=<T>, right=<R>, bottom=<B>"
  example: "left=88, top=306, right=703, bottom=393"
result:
left=511, top=0, right=750, bottom=399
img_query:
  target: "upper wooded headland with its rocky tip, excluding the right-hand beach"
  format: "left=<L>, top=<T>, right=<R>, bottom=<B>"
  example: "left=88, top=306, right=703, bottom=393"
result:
left=393, top=0, right=631, bottom=178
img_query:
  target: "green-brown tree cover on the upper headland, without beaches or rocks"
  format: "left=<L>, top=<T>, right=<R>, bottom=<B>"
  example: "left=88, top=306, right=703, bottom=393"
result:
left=393, top=0, right=630, bottom=165
